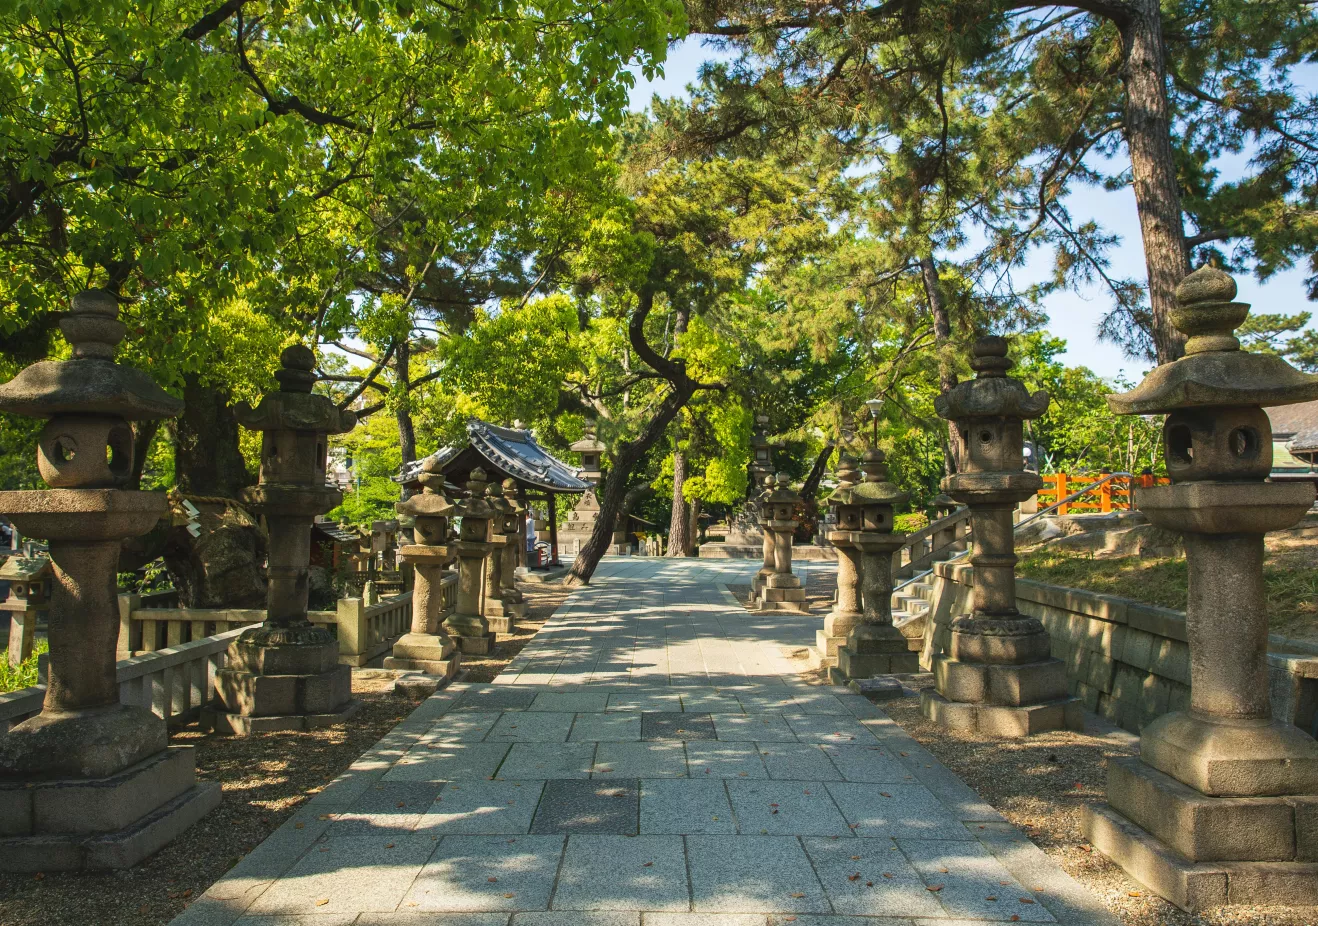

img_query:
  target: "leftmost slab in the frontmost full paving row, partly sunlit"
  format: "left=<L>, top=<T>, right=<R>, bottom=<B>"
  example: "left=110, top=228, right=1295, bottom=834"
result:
left=248, top=834, right=435, bottom=914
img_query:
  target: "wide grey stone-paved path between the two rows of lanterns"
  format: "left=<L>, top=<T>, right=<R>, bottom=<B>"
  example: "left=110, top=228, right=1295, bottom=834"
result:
left=174, top=558, right=1115, bottom=926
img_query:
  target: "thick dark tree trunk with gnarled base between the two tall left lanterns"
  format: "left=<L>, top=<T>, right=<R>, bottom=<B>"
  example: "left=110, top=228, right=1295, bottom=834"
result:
left=162, top=377, right=268, bottom=607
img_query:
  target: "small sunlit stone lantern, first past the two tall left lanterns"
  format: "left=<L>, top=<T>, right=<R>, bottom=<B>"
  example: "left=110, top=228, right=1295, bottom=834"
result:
left=385, top=457, right=460, bottom=680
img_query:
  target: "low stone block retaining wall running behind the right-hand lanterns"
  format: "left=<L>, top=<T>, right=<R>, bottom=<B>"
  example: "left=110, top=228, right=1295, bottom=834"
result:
left=920, top=562, right=1318, bottom=734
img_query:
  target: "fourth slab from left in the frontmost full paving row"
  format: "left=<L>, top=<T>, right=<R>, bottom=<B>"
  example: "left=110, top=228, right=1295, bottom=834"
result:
left=687, top=836, right=832, bottom=913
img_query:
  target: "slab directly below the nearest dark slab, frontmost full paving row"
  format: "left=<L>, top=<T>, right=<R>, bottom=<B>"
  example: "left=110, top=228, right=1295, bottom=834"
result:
left=554, top=835, right=691, bottom=910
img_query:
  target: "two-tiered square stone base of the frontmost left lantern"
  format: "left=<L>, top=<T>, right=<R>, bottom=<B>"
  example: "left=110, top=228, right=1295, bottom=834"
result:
left=0, top=746, right=220, bottom=872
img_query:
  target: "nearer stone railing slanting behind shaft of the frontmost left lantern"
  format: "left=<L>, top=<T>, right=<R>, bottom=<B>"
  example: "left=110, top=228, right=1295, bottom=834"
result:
left=0, top=627, right=243, bottom=731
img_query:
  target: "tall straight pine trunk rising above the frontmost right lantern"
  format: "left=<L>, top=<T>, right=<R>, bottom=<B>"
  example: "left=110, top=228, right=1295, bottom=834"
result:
left=1118, top=0, right=1190, bottom=364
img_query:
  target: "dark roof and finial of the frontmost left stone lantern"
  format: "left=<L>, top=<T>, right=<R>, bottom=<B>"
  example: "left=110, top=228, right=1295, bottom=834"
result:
left=0, top=290, right=183, bottom=422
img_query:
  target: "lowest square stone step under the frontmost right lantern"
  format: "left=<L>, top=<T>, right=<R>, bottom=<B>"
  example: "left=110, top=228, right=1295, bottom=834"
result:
left=1081, top=803, right=1318, bottom=913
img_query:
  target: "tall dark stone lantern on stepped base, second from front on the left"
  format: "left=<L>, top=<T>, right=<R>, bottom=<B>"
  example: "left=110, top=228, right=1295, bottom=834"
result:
left=207, top=344, right=361, bottom=735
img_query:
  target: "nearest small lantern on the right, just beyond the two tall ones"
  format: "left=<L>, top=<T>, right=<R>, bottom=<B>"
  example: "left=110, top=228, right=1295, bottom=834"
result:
left=832, top=449, right=920, bottom=681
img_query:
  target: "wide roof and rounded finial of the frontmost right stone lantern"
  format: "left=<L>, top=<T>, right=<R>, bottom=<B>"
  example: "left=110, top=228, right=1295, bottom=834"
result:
left=1107, top=266, right=1318, bottom=415
